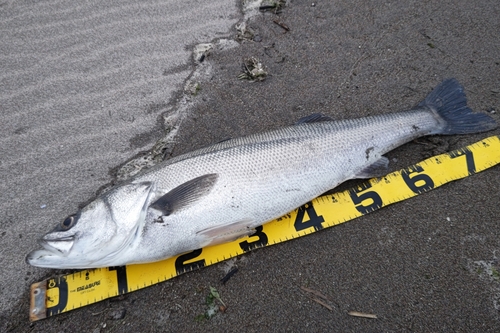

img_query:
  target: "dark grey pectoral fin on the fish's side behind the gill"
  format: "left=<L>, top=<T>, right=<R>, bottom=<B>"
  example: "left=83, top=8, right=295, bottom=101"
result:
left=150, top=173, right=219, bottom=216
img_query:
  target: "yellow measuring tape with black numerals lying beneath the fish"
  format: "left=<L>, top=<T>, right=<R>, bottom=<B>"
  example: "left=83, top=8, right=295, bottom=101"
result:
left=30, top=136, right=500, bottom=321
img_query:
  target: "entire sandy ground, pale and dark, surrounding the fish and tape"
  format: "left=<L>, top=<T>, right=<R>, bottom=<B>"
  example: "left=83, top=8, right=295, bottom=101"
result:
left=0, top=0, right=500, bottom=332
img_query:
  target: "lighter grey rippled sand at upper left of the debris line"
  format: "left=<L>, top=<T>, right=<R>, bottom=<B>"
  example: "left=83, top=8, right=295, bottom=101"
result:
left=0, top=1, right=240, bottom=324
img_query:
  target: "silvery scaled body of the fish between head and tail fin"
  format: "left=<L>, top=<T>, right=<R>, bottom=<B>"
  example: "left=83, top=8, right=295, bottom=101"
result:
left=127, top=110, right=456, bottom=260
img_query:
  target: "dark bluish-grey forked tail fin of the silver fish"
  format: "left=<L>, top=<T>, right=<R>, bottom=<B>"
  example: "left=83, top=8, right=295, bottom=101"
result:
left=418, top=79, right=497, bottom=135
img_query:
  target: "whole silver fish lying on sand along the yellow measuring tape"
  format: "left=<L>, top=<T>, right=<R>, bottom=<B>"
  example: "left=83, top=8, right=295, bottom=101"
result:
left=26, top=79, right=497, bottom=269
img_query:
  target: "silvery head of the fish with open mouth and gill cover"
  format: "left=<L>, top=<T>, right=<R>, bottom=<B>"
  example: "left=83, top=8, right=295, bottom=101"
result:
left=26, top=182, right=153, bottom=269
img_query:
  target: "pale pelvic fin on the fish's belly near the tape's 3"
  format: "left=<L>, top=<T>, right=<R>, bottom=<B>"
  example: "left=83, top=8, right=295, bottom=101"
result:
left=196, top=219, right=255, bottom=246
